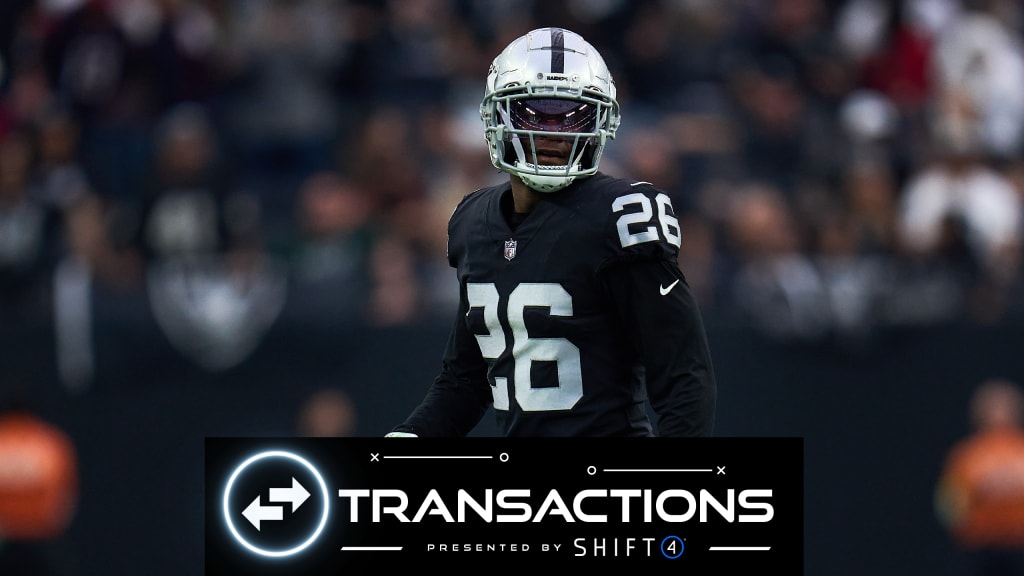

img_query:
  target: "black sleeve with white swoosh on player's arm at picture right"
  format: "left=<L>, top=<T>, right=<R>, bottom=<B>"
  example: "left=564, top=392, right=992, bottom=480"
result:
left=604, top=259, right=717, bottom=437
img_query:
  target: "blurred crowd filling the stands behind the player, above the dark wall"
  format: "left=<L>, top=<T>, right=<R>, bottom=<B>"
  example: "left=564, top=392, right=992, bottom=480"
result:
left=0, top=0, right=1024, bottom=348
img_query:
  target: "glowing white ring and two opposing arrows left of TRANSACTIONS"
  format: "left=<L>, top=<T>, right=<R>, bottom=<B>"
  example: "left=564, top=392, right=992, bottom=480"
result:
left=223, top=450, right=330, bottom=558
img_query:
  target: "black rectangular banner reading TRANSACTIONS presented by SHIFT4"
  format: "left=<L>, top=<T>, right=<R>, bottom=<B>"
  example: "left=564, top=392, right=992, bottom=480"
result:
left=206, top=438, right=804, bottom=576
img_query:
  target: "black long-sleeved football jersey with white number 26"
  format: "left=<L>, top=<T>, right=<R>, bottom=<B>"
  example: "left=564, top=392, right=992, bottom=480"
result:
left=387, top=173, right=715, bottom=437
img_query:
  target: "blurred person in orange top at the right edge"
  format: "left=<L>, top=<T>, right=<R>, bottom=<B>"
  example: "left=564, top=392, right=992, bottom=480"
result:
left=936, top=378, right=1024, bottom=576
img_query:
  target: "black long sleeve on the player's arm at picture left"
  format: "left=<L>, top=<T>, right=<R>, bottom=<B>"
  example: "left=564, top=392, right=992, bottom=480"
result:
left=392, top=287, right=493, bottom=437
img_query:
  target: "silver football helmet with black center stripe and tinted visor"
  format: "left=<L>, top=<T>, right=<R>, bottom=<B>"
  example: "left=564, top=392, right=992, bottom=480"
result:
left=480, top=28, right=620, bottom=192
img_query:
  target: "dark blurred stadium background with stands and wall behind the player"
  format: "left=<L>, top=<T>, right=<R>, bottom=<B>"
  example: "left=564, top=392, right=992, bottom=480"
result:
left=0, top=0, right=1024, bottom=576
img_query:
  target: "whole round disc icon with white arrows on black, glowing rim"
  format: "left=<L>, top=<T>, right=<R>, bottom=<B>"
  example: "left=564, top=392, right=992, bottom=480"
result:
left=223, top=450, right=330, bottom=558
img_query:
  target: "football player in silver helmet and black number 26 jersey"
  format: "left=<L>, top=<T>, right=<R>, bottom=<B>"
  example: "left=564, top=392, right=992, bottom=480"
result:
left=387, top=28, right=716, bottom=437
